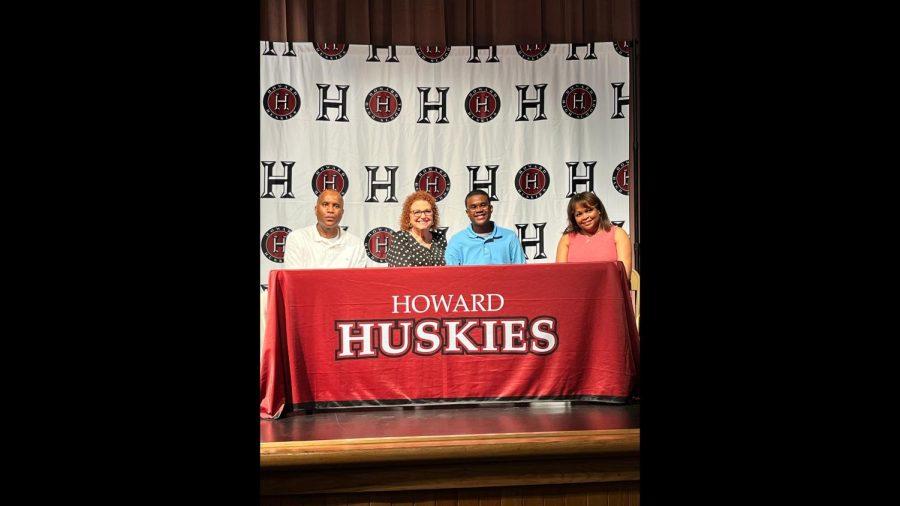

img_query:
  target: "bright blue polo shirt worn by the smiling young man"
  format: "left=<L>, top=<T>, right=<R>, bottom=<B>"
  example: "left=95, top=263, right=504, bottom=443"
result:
left=444, top=222, right=525, bottom=265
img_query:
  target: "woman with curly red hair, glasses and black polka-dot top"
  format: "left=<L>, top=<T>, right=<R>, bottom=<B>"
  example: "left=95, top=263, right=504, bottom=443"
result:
left=387, top=191, right=447, bottom=267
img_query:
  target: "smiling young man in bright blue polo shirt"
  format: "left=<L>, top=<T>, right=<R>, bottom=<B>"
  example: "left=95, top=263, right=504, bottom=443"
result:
left=444, top=190, right=525, bottom=265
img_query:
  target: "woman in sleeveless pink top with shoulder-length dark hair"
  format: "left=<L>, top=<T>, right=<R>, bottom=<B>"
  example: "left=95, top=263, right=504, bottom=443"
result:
left=556, top=192, right=631, bottom=279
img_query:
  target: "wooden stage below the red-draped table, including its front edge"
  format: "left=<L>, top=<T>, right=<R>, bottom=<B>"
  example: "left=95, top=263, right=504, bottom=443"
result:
left=259, top=402, right=640, bottom=498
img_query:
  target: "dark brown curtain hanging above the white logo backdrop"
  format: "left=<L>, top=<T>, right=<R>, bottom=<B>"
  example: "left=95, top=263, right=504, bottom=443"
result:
left=260, top=0, right=636, bottom=46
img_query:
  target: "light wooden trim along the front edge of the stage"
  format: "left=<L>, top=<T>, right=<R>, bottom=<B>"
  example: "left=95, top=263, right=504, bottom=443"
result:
left=260, top=429, right=640, bottom=471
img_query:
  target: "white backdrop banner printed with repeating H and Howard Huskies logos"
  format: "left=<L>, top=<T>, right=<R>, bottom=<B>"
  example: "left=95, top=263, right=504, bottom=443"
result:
left=258, top=42, right=630, bottom=288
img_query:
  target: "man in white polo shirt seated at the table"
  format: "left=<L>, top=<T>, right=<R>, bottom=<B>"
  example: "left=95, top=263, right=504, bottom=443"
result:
left=283, top=190, right=366, bottom=269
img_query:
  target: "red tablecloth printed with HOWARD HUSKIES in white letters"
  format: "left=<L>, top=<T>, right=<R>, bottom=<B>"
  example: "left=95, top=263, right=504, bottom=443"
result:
left=260, top=262, right=640, bottom=418
